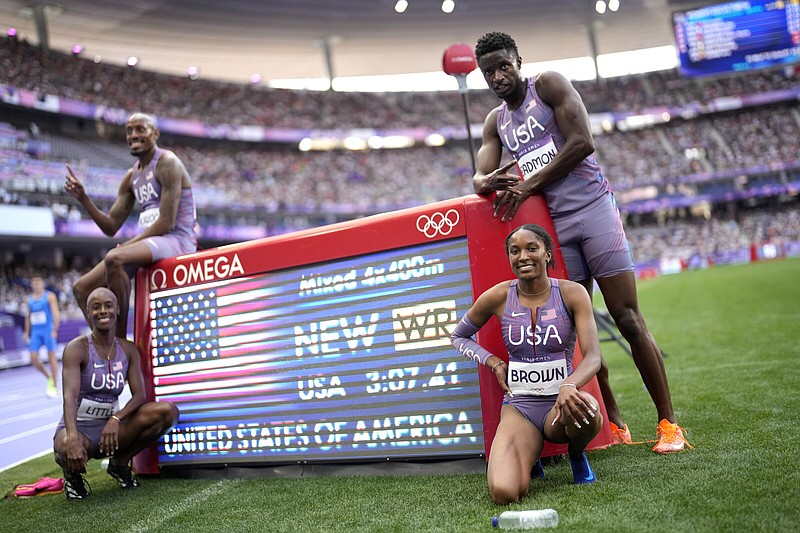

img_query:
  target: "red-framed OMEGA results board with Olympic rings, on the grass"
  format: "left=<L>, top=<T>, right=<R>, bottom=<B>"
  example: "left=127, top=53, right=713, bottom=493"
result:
left=135, top=196, right=612, bottom=472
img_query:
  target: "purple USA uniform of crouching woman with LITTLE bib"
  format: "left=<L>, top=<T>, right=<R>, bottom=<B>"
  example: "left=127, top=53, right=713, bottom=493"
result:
left=53, top=333, right=128, bottom=445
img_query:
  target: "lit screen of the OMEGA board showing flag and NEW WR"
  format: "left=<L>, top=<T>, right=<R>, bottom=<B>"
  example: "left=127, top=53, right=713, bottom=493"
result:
left=140, top=204, right=484, bottom=466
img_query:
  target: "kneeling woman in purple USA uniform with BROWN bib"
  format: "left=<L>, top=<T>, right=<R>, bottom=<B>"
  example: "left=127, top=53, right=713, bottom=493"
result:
left=451, top=224, right=603, bottom=504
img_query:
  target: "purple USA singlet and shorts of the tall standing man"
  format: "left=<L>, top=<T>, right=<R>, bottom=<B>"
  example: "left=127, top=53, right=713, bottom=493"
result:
left=497, top=78, right=633, bottom=281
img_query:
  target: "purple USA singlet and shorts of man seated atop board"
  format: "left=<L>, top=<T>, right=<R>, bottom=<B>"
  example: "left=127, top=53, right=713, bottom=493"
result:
left=131, top=148, right=197, bottom=262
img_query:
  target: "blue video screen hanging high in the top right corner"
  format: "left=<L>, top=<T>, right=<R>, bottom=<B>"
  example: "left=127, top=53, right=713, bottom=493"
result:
left=672, top=0, right=800, bottom=76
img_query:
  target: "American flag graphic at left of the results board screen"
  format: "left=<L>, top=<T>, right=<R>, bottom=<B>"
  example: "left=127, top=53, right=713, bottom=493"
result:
left=150, top=278, right=293, bottom=401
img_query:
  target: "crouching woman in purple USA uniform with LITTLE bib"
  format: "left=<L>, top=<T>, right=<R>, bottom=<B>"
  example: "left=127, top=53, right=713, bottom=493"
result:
left=53, top=287, right=178, bottom=500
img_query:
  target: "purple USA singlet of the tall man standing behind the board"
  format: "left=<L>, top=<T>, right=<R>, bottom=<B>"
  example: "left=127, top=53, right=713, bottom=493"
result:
left=497, top=78, right=610, bottom=218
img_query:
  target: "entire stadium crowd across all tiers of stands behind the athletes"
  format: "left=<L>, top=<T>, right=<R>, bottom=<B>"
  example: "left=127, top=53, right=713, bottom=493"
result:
left=0, top=34, right=800, bottom=308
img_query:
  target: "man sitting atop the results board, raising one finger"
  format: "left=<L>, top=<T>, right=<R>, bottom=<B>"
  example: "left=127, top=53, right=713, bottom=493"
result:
left=64, top=113, right=197, bottom=338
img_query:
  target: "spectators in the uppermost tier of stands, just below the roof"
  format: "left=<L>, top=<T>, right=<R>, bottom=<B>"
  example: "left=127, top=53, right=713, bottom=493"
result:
left=0, top=38, right=797, bottom=125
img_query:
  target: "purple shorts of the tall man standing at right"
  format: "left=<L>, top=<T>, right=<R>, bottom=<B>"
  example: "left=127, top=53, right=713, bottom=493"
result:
left=553, top=194, right=633, bottom=281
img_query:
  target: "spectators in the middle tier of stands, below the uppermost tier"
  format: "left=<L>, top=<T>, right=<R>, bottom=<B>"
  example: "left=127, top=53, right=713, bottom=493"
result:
left=0, top=105, right=800, bottom=215
